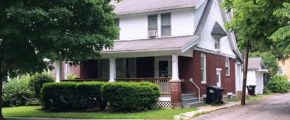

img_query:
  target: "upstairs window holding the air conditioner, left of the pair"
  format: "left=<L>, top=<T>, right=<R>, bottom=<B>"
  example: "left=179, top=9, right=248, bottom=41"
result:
left=148, top=14, right=158, bottom=37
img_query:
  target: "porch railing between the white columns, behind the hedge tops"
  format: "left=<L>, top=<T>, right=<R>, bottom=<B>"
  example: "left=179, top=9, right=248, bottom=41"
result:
left=116, top=77, right=171, bottom=95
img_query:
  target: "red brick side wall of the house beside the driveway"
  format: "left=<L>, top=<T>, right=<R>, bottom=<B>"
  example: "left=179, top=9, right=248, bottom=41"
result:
left=179, top=51, right=235, bottom=94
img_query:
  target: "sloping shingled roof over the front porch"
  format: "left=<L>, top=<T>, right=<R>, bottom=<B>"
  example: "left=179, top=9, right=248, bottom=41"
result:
left=101, top=35, right=199, bottom=54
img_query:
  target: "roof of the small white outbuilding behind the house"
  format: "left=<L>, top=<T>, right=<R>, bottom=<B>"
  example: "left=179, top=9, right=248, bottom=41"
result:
left=248, top=57, right=266, bottom=70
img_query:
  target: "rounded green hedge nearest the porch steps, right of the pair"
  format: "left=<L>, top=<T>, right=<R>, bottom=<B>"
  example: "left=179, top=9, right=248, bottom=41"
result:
left=103, top=82, right=160, bottom=112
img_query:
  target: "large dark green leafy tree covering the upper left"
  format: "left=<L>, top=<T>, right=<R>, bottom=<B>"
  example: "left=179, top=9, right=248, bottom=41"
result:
left=0, top=0, right=118, bottom=119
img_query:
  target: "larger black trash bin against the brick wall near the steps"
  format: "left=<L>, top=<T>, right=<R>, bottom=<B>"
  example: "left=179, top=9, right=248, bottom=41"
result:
left=206, top=86, right=225, bottom=104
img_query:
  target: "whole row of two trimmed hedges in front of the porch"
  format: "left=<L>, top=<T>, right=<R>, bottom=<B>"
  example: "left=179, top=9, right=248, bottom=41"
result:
left=41, top=82, right=160, bottom=112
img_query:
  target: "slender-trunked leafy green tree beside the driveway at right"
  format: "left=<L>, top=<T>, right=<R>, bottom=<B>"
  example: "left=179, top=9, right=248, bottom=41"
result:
left=223, top=0, right=286, bottom=105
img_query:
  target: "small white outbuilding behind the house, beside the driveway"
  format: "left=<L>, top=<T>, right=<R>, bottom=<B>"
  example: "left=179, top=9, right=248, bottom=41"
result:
left=247, top=57, right=268, bottom=94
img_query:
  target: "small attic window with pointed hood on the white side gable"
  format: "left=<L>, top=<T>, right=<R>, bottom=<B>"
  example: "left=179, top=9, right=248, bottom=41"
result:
left=211, top=22, right=227, bottom=50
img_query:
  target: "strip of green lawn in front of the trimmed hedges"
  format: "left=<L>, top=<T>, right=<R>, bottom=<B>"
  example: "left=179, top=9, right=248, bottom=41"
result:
left=3, top=106, right=196, bottom=119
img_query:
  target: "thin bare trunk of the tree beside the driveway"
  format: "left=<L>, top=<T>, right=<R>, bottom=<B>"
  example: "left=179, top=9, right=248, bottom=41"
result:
left=241, top=40, right=250, bottom=105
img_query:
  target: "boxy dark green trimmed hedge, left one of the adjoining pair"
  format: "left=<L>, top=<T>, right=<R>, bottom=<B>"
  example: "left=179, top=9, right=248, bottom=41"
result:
left=41, top=82, right=105, bottom=111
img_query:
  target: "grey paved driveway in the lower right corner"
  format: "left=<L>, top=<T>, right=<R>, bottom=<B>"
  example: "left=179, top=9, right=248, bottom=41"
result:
left=193, top=93, right=290, bottom=120
